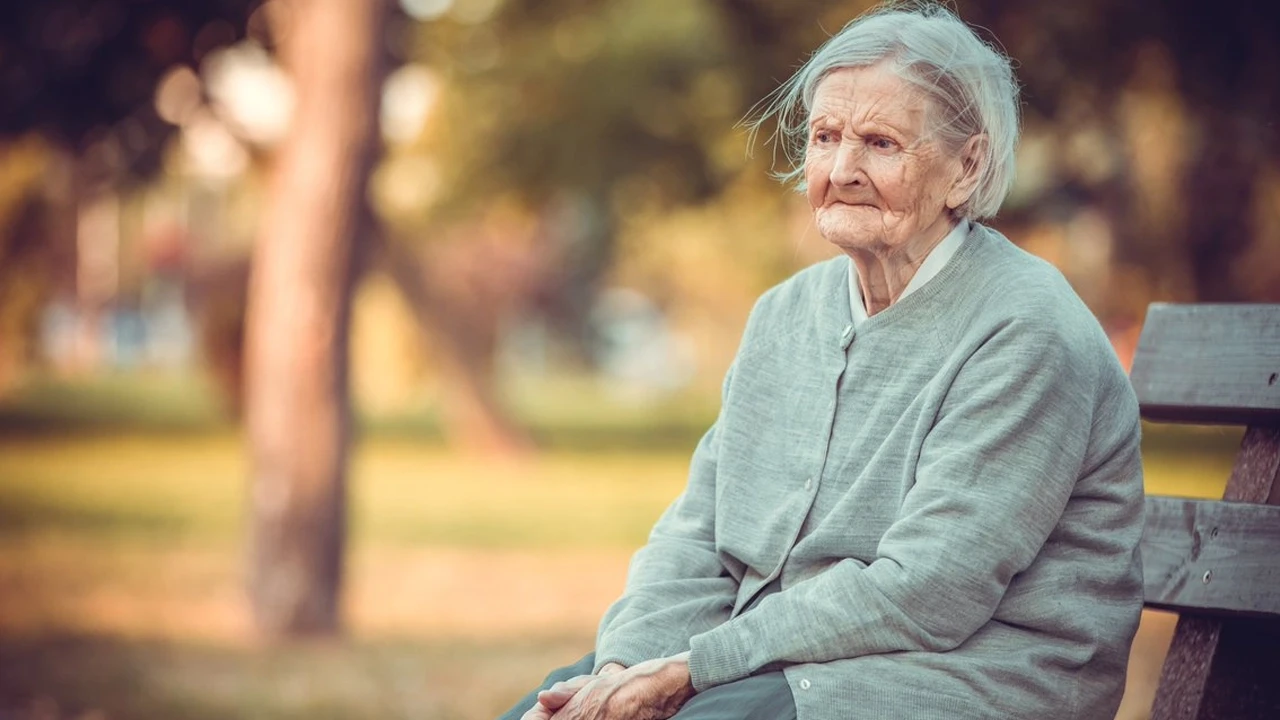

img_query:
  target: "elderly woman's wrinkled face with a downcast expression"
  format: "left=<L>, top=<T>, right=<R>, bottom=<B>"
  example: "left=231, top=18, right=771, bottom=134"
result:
left=804, top=63, right=972, bottom=252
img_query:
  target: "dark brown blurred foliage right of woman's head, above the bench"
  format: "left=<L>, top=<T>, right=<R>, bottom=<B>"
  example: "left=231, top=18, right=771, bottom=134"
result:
left=960, top=0, right=1280, bottom=310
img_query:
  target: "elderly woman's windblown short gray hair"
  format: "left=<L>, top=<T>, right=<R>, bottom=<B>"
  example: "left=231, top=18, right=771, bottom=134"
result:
left=748, top=3, right=1018, bottom=220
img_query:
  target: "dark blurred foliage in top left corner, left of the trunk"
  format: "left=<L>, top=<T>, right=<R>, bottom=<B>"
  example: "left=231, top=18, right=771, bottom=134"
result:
left=0, top=0, right=262, bottom=386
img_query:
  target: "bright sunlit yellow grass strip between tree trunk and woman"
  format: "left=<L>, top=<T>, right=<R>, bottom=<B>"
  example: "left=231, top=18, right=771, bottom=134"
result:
left=353, top=442, right=686, bottom=548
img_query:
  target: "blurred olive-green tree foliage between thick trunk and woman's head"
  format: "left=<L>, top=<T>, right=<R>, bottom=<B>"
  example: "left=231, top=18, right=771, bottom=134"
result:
left=421, top=0, right=739, bottom=356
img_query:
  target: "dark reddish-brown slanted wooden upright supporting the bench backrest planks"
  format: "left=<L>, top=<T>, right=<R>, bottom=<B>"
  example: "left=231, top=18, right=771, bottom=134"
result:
left=1151, top=425, right=1280, bottom=720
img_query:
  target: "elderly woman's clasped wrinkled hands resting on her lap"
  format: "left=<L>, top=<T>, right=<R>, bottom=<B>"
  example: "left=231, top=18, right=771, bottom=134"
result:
left=521, top=652, right=694, bottom=720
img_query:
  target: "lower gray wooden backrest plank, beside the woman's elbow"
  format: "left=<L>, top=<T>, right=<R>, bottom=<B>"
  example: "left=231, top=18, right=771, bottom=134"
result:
left=1142, top=497, right=1280, bottom=615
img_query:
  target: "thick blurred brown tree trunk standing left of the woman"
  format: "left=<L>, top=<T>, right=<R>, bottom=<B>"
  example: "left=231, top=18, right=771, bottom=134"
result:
left=246, top=0, right=388, bottom=637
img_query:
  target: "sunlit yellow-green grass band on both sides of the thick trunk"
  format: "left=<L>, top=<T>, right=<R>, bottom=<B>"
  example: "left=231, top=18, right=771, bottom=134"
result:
left=0, top=433, right=686, bottom=548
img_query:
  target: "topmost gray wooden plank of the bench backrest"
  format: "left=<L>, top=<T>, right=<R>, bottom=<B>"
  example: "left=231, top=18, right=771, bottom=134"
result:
left=1130, top=302, right=1280, bottom=425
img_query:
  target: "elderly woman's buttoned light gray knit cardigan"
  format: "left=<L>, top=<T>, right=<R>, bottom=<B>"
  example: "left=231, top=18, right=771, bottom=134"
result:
left=596, top=224, right=1143, bottom=720
